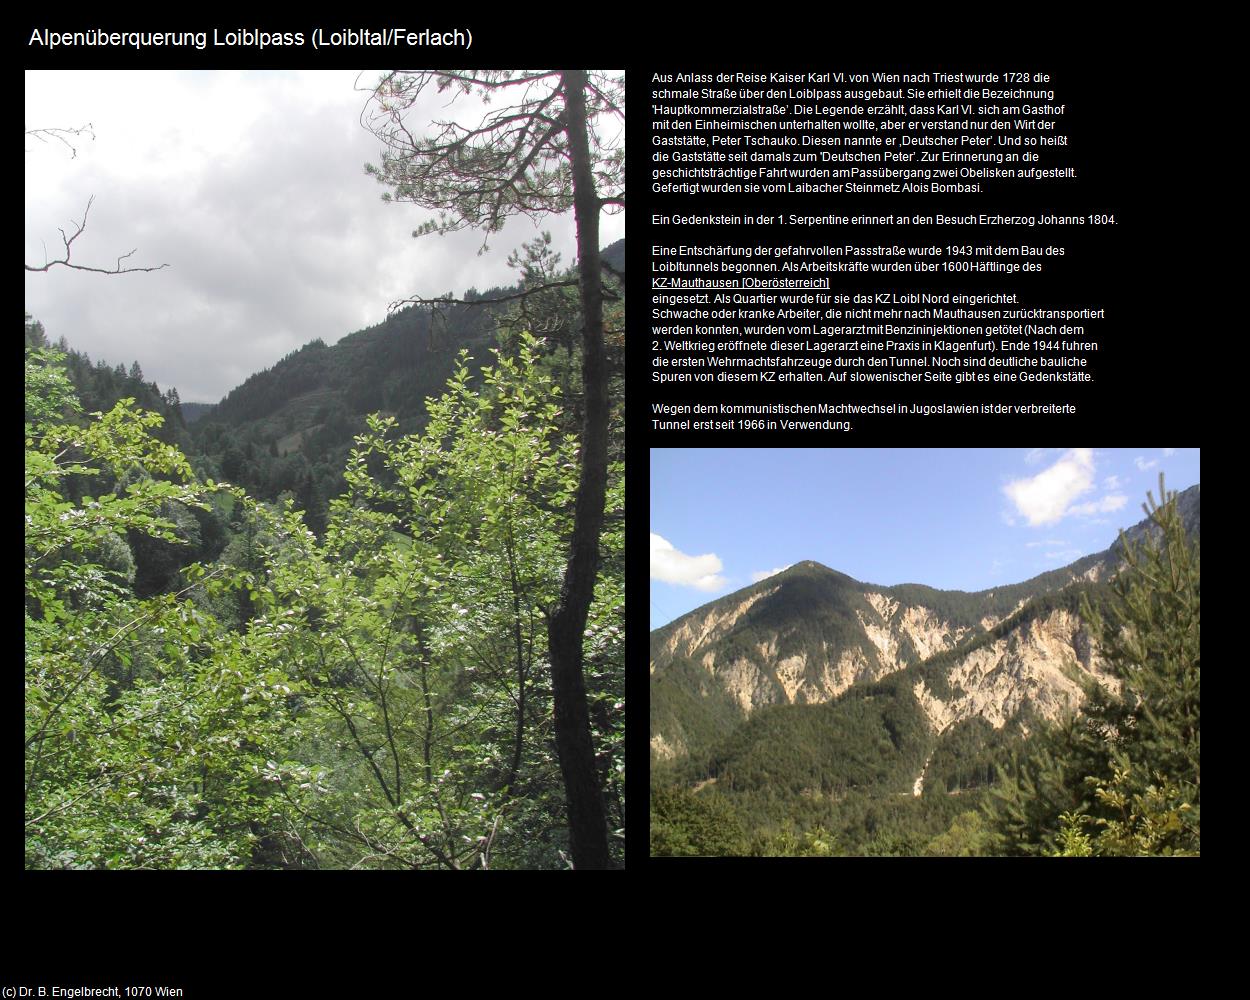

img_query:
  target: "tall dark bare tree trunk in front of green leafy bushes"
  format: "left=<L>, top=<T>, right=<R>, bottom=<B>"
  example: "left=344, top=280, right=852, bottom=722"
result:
left=548, top=70, right=611, bottom=869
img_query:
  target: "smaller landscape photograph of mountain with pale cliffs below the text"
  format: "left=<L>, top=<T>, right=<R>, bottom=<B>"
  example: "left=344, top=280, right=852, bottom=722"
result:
left=649, top=448, right=1201, bottom=859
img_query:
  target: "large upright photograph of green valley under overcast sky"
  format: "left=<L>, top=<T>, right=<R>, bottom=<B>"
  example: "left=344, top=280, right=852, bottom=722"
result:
left=24, top=70, right=626, bottom=870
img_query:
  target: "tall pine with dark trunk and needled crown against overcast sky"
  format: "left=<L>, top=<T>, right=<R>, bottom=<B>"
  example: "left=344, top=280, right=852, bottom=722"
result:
left=365, top=70, right=625, bottom=869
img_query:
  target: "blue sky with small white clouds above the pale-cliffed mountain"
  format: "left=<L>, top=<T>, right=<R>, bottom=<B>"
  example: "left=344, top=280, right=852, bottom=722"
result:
left=651, top=448, right=1199, bottom=629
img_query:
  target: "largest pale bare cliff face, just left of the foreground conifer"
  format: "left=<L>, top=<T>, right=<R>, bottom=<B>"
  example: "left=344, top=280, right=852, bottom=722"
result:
left=914, top=610, right=1119, bottom=733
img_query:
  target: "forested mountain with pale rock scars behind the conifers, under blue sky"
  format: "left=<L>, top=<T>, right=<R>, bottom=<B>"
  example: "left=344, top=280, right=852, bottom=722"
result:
left=650, top=486, right=1200, bottom=854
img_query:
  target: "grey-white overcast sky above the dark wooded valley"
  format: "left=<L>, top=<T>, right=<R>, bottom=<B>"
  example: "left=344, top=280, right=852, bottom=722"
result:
left=25, top=70, right=625, bottom=403
